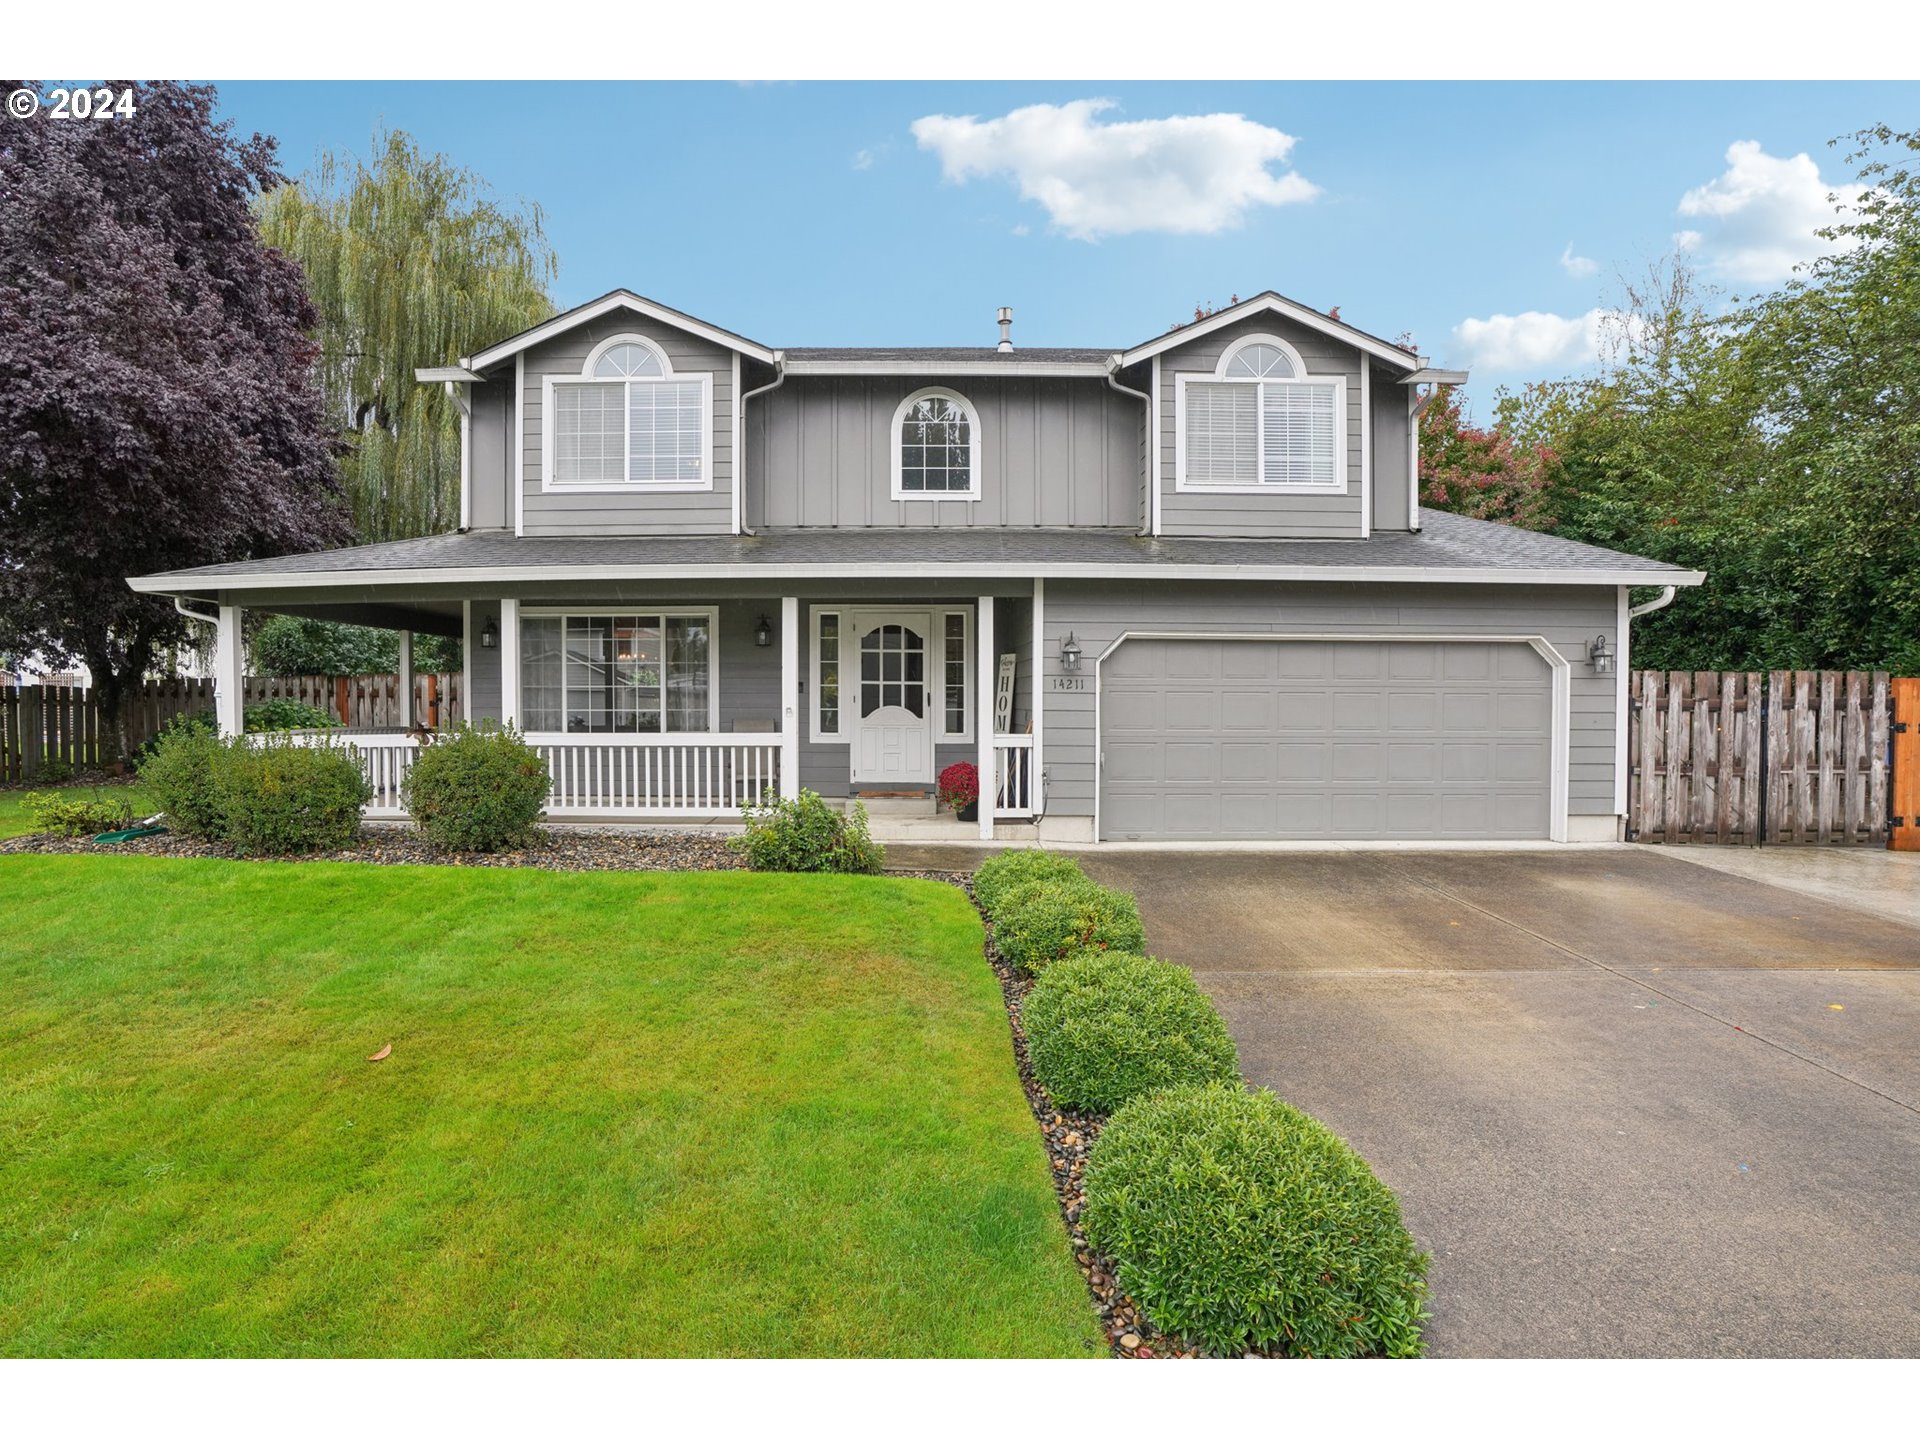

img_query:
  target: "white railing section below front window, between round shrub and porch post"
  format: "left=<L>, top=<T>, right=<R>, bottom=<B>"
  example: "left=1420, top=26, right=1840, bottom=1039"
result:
left=526, top=735, right=780, bottom=818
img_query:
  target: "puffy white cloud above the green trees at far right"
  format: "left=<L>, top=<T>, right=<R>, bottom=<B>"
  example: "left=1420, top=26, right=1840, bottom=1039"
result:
left=1674, top=140, right=1860, bottom=284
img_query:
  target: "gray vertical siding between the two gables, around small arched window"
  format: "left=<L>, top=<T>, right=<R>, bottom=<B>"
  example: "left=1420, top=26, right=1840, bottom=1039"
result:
left=747, top=376, right=1146, bottom=530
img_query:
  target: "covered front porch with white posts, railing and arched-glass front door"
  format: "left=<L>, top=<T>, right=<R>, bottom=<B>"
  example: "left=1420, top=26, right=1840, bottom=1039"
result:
left=205, top=580, right=1044, bottom=839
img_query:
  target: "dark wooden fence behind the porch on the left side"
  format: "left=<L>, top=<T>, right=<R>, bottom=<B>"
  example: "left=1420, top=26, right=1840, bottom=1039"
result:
left=0, top=674, right=463, bottom=783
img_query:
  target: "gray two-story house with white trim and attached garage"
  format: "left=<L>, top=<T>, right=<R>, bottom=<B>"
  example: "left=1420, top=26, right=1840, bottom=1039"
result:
left=132, top=290, right=1703, bottom=841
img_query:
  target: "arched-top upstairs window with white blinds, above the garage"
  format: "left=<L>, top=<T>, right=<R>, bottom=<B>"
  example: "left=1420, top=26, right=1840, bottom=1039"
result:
left=1175, top=334, right=1346, bottom=492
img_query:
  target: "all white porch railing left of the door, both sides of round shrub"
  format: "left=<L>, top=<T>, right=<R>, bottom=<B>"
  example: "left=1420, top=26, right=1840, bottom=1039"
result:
left=253, top=730, right=780, bottom=820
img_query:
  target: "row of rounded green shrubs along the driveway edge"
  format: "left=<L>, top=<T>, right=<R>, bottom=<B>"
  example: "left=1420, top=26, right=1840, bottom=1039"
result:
left=973, top=851, right=1427, bottom=1356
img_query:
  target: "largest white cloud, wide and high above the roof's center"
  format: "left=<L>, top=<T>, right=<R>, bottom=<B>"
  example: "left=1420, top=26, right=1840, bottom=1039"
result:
left=912, top=100, right=1319, bottom=240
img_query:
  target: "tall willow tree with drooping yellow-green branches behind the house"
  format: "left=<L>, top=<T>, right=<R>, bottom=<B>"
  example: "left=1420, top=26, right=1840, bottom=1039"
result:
left=257, top=131, right=557, bottom=541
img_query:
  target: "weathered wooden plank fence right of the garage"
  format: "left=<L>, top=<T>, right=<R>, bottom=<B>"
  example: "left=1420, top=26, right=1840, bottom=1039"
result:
left=1626, top=670, right=1893, bottom=845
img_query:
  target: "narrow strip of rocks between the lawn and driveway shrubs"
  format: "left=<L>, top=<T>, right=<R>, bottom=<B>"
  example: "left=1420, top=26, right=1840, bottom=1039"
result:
left=936, top=872, right=1198, bottom=1359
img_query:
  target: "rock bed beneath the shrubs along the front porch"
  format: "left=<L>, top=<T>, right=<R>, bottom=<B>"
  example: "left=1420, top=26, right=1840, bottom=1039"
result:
left=0, top=826, right=747, bottom=870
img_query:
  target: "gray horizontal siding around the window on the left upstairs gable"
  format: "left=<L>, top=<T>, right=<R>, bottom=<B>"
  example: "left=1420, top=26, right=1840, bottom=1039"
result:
left=509, top=313, right=733, bottom=536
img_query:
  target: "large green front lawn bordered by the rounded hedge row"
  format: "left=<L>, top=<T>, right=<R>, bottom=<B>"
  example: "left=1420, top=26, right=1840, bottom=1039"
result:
left=0, top=856, right=1104, bottom=1356
